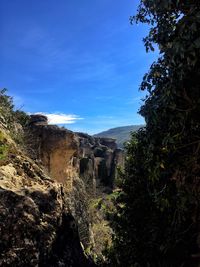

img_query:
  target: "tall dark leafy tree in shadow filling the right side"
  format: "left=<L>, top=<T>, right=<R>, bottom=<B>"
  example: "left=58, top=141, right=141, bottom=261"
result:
left=109, top=0, right=200, bottom=267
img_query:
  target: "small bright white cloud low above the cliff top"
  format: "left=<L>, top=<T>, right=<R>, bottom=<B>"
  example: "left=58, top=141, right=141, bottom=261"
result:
left=35, top=112, right=83, bottom=124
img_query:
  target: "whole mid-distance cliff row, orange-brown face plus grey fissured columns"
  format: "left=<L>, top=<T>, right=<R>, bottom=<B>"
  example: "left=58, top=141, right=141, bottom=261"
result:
left=29, top=115, right=123, bottom=193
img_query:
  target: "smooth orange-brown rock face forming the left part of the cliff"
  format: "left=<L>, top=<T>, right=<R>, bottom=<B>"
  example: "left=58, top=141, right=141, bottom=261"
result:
left=28, top=122, right=78, bottom=186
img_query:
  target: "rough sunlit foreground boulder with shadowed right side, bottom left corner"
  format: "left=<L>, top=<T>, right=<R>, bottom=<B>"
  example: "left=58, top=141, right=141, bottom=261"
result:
left=0, top=153, right=94, bottom=267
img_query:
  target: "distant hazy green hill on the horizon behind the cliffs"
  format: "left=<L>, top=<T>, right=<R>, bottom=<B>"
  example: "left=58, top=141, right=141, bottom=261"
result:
left=94, top=125, right=144, bottom=148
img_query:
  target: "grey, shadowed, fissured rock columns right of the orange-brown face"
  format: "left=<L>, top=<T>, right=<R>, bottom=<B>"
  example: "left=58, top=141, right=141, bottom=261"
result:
left=77, top=133, right=124, bottom=192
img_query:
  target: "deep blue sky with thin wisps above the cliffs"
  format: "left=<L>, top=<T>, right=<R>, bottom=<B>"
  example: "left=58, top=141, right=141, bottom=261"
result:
left=0, top=0, right=156, bottom=134
